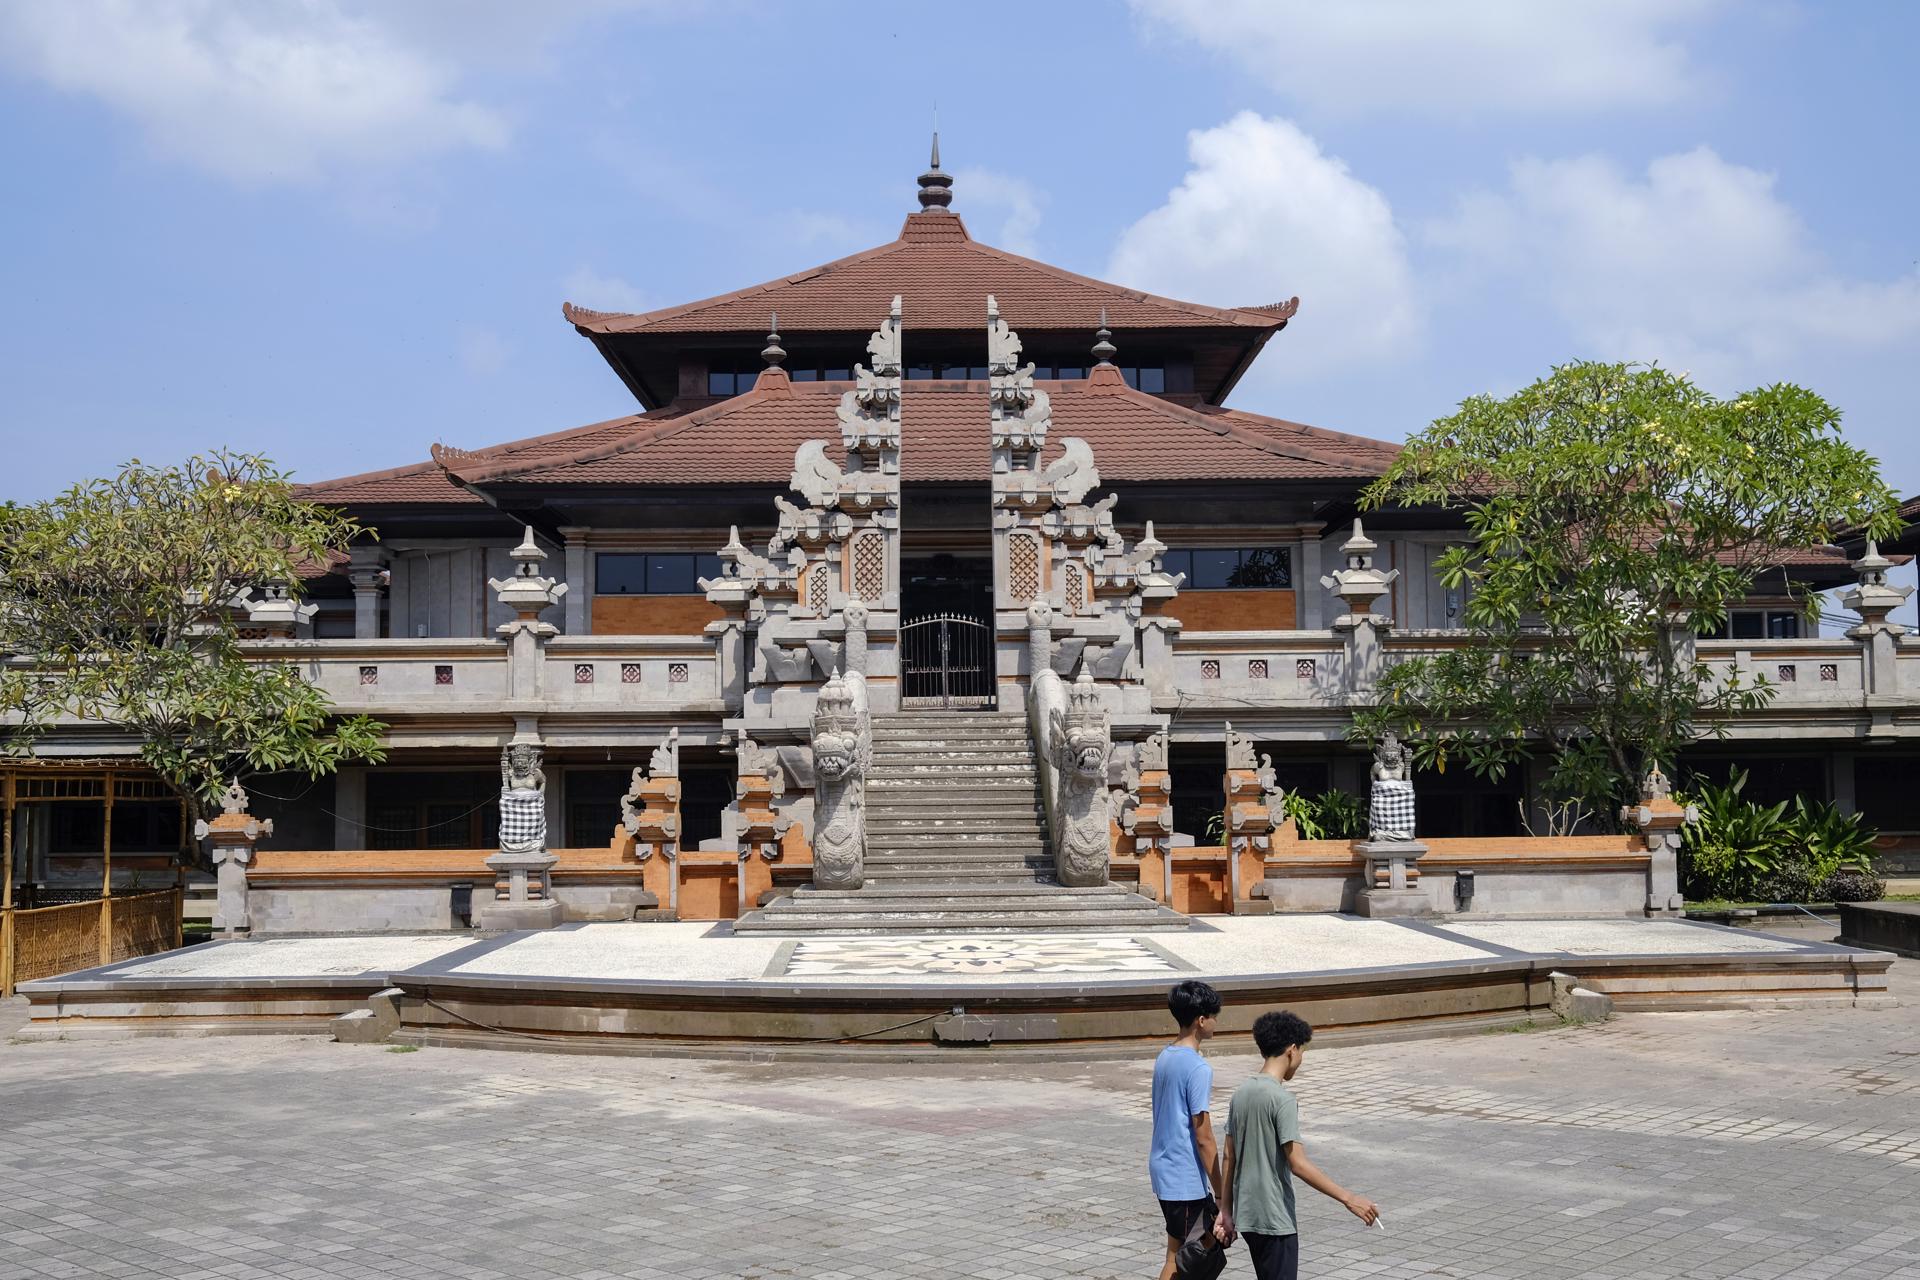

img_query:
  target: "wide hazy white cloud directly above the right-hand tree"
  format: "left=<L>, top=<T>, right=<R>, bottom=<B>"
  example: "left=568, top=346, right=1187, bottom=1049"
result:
left=1427, top=148, right=1920, bottom=390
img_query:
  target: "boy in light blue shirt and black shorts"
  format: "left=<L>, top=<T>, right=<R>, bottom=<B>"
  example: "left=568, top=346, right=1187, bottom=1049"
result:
left=1146, top=979, right=1219, bottom=1280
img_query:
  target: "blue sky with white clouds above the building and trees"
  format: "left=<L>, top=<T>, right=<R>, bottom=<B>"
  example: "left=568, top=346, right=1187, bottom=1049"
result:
left=0, top=0, right=1920, bottom=497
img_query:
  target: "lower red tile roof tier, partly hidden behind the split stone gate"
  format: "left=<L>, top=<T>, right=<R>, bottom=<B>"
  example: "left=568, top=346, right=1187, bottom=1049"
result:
left=434, top=367, right=1398, bottom=487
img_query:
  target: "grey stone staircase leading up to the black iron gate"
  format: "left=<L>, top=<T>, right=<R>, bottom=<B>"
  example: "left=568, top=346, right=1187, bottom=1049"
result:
left=733, top=712, right=1187, bottom=935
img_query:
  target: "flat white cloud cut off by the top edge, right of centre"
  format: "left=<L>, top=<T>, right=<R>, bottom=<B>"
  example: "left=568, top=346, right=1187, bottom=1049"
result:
left=1133, top=0, right=1720, bottom=115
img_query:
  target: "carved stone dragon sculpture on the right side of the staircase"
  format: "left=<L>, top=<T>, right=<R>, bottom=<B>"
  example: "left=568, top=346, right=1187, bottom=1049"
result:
left=1031, top=668, right=1114, bottom=885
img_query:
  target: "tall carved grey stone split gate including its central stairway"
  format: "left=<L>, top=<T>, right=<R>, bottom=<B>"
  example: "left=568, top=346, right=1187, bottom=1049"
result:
left=701, top=296, right=1181, bottom=931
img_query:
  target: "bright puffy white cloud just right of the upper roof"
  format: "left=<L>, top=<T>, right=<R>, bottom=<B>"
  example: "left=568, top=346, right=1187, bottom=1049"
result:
left=1108, top=111, right=1421, bottom=378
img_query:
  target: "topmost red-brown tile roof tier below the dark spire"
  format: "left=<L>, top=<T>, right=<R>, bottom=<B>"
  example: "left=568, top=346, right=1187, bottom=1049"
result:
left=561, top=211, right=1300, bottom=337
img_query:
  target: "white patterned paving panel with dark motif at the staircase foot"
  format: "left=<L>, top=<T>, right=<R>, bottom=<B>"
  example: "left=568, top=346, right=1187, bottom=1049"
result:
left=781, top=935, right=1175, bottom=977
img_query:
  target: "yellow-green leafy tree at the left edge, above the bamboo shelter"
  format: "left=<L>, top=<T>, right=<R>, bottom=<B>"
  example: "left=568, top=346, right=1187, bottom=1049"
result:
left=0, top=451, right=386, bottom=852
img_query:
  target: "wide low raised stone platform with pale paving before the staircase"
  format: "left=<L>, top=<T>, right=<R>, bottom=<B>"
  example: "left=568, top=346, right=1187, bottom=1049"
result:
left=21, top=915, right=1893, bottom=1057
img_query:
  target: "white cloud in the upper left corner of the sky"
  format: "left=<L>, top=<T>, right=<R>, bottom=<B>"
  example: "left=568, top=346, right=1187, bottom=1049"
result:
left=0, top=0, right=509, bottom=182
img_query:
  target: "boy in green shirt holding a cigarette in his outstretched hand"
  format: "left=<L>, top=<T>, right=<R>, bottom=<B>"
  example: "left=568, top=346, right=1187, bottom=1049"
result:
left=1213, top=1013, right=1380, bottom=1280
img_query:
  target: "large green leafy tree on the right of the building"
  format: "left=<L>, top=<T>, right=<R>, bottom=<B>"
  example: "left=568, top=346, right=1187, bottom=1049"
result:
left=1354, top=363, right=1897, bottom=814
